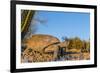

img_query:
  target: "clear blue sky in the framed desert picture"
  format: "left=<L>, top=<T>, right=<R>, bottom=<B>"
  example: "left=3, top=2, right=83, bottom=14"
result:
left=32, top=11, right=90, bottom=40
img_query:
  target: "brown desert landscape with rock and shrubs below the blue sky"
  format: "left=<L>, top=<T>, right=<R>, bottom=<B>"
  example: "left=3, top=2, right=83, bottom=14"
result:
left=21, top=34, right=90, bottom=62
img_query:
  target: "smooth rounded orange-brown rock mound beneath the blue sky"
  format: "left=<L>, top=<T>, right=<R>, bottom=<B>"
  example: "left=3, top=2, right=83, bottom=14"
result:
left=22, top=34, right=60, bottom=50
